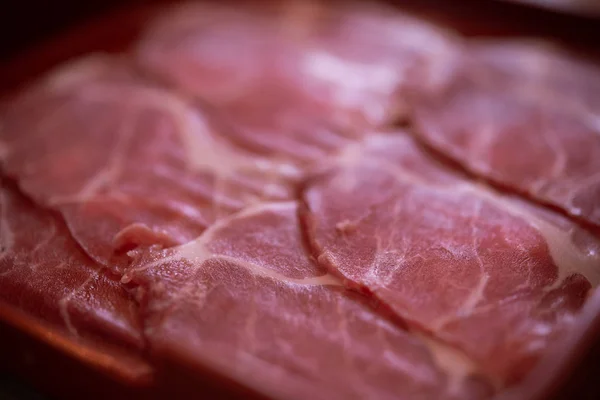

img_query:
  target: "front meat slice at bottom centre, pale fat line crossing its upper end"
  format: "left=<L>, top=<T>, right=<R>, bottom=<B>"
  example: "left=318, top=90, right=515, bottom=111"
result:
left=124, top=202, right=491, bottom=399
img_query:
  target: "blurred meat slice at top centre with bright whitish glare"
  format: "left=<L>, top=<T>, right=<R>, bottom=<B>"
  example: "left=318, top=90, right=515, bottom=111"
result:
left=137, top=1, right=455, bottom=160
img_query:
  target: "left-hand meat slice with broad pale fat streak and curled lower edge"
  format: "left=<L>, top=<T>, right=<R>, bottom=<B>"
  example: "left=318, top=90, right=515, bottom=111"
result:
left=0, top=56, right=298, bottom=263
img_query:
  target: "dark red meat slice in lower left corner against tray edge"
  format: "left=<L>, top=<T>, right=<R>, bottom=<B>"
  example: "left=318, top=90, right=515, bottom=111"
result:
left=0, top=179, right=151, bottom=380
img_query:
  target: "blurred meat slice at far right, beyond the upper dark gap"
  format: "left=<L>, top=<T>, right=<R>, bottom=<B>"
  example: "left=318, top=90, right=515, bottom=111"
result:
left=415, top=41, right=600, bottom=226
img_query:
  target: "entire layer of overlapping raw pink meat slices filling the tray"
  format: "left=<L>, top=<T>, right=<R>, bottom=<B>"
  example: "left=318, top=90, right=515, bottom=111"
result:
left=0, top=1, right=600, bottom=399
